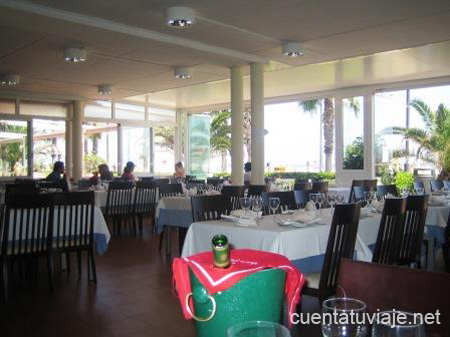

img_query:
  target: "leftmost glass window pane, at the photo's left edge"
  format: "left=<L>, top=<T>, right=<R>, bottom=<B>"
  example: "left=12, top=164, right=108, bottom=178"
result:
left=0, top=120, right=28, bottom=177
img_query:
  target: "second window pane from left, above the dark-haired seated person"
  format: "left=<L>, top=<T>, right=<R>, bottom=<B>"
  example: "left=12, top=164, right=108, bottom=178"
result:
left=33, top=119, right=66, bottom=178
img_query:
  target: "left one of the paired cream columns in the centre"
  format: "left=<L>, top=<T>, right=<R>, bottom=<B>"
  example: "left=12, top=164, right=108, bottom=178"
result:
left=230, top=67, right=244, bottom=185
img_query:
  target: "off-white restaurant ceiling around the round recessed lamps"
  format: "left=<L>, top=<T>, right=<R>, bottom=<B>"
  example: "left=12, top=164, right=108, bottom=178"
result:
left=0, top=0, right=450, bottom=99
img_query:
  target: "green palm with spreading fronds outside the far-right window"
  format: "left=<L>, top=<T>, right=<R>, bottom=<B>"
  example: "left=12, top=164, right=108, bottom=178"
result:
left=383, top=99, right=450, bottom=171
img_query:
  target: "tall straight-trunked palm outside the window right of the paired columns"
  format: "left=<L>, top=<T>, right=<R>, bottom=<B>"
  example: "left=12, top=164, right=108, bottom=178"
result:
left=298, top=98, right=361, bottom=171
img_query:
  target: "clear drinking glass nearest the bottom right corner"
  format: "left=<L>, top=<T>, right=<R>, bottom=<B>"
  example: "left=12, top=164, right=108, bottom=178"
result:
left=372, top=311, right=425, bottom=337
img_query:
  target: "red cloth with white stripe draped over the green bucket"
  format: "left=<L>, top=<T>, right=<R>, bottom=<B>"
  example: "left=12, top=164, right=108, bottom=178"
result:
left=173, top=249, right=305, bottom=321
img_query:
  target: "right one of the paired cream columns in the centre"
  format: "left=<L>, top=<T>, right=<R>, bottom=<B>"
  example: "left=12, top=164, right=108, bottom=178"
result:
left=250, top=63, right=265, bottom=185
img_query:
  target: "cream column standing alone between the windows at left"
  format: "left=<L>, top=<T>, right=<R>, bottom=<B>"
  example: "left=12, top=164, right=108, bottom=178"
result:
left=72, top=101, right=84, bottom=181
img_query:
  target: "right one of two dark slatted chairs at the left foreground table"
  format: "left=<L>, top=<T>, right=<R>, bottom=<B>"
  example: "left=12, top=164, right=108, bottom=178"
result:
left=53, top=191, right=97, bottom=283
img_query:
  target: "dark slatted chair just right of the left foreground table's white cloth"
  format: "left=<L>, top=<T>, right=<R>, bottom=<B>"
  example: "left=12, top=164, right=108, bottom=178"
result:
left=104, top=181, right=134, bottom=235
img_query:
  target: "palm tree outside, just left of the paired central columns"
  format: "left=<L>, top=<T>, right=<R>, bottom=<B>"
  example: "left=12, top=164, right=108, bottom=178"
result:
left=210, top=110, right=231, bottom=172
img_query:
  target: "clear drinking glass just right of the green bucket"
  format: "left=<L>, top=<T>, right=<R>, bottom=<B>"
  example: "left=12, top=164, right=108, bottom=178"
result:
left=322, top=297, right=367, bottom=337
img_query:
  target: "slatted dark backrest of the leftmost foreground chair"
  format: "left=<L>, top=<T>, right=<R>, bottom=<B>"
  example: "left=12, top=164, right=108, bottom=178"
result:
left=1, top=193, right=55, bottom=257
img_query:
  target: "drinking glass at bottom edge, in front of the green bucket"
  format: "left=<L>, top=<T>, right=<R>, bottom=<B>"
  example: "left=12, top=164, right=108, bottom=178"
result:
left=227, top=321, right=291, bottom=337
